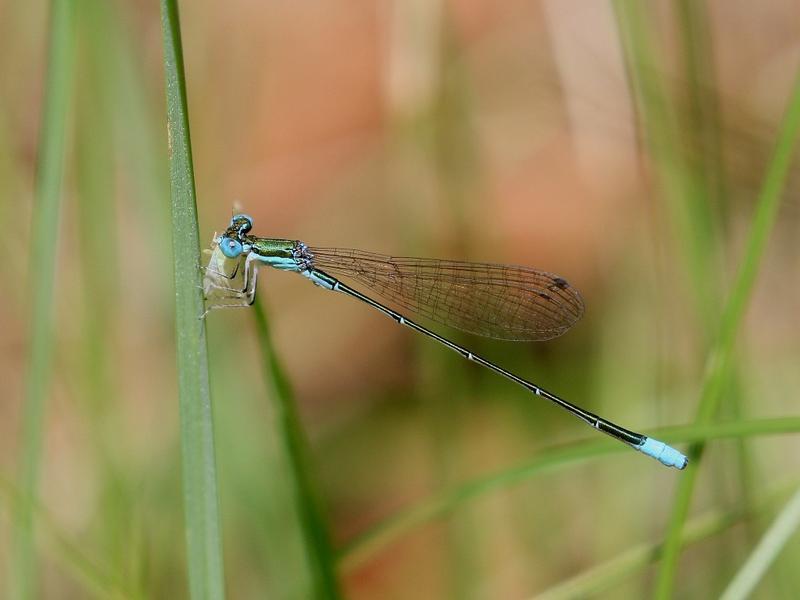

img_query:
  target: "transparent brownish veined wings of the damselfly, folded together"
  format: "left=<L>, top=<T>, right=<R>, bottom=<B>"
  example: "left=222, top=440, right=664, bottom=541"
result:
left=309, top=248, right=583, bottom=341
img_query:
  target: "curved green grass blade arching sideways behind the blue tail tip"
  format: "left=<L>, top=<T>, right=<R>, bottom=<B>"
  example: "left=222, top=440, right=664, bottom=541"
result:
left=339, top=417, right=800, bottom=570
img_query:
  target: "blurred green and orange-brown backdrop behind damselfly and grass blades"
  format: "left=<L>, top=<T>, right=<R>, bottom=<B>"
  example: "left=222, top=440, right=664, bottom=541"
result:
left=0, top=0, right=800, bottom=599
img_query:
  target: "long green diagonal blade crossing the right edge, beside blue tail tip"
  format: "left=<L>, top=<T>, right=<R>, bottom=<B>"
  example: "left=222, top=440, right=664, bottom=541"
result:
left=656, top=77, right=800, bottom=598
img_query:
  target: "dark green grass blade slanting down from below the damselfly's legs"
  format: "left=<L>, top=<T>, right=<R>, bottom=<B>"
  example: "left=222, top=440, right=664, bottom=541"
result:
left=255, top=300, right=340, bottom=599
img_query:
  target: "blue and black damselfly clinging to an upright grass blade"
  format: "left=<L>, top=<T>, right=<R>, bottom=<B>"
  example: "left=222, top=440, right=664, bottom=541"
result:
left=203, top=215, right=687, bottom=469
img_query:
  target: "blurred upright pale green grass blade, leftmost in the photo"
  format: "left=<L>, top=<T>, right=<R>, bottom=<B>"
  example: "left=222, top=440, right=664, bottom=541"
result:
left=9, top=0, right=75, bottom=599
